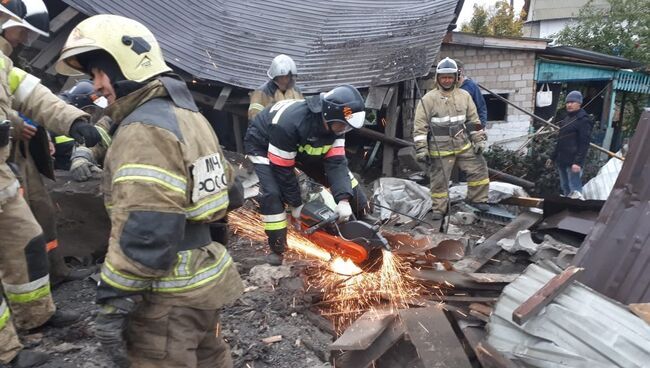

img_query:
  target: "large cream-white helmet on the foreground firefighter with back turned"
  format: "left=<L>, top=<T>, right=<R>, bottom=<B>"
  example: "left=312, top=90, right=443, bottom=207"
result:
left=56, top=14, right=171, bottom=82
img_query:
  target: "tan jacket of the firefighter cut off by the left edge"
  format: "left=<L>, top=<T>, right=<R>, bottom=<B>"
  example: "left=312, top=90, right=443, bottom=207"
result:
left=0, top=37, right=89, bottom=204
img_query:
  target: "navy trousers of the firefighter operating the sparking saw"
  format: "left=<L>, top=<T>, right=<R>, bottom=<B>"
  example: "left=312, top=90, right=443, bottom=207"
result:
left=254, top=164, right=368, bottom=254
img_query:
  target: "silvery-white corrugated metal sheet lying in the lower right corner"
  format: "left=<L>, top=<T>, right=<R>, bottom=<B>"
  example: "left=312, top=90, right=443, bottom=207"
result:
left=487, top=264, right=650, bottom=368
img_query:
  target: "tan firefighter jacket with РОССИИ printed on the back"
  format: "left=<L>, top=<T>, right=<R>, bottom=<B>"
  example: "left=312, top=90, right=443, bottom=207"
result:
left=97, top=76, right=242, bottom=309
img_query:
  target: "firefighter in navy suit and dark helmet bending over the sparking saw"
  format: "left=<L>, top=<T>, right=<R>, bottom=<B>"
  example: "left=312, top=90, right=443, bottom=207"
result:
left=244, top=85, right=368, bottom=265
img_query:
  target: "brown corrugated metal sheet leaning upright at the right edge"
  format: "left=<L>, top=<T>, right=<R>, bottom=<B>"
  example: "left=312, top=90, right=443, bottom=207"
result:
left=574, top=109, right=650, bottom=304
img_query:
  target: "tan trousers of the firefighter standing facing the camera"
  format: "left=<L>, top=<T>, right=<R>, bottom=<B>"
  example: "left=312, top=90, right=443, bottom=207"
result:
left=429, top=148, right=490, bottom=214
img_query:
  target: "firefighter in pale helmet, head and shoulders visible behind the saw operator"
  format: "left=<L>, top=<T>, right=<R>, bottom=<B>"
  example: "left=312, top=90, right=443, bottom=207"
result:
left=248, top=54, right=303, bottom=121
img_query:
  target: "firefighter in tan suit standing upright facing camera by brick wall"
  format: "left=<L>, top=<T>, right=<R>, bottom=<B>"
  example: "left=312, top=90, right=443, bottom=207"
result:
left=413, top=58, right=490, bottom=219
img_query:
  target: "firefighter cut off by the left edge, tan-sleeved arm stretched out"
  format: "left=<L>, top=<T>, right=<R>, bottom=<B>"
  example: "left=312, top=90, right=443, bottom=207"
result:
left=0, top=0, right=100, bottom=367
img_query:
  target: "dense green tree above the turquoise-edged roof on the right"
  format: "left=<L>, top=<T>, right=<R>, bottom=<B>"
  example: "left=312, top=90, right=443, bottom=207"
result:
left=555, top=0, right=650, bottom=135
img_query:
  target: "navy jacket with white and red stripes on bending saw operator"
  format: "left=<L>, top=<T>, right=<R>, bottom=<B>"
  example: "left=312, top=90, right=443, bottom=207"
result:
left=244, top=96, right=353, bottom=207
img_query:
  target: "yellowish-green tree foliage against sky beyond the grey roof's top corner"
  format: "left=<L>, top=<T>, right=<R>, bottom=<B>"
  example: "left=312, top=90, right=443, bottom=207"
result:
left=460, top=0, right=526, bottom=37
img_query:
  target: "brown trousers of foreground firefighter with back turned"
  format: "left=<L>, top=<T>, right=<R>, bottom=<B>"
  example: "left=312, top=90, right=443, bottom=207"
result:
left=126, top=301, right=233, bottom=368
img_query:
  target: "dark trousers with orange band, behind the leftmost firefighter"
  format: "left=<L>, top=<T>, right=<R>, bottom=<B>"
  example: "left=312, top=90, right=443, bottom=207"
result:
left=13, top=142, right=70, bottom=284
